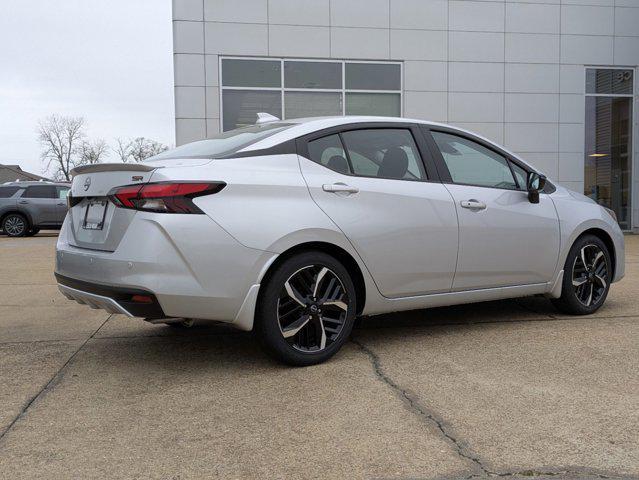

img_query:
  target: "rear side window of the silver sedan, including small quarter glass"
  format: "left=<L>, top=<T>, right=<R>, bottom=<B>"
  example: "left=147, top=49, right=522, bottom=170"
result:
left=308, top=128, right=426, bottom=180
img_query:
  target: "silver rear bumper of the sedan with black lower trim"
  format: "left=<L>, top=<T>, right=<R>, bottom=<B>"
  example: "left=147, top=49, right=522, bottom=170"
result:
left=55, top=212, right=277, bottom=330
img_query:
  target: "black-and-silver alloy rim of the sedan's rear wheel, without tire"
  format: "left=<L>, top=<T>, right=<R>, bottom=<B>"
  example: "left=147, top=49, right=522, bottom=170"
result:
left=277, top=265, right=349, bottom=352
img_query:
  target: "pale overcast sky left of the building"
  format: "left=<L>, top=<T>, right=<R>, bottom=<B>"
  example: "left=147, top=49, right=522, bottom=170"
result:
left=0, top=0, right=175, bottom=173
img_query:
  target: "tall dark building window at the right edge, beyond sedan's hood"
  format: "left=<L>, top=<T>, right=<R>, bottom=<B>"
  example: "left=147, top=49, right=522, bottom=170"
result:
left=584, top=68, right=634, bottom=230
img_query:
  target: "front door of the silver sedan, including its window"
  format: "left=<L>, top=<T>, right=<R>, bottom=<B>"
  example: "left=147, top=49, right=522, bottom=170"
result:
left=431, top=131, right=559, bottom=291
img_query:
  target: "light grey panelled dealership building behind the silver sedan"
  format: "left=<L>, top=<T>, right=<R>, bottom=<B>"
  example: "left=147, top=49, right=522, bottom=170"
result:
left=173, top=0, right=639, bottom=231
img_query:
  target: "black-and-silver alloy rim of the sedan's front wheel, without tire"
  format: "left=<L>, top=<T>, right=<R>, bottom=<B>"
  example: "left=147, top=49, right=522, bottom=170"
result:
left=572, top=244, right=609, bottom=307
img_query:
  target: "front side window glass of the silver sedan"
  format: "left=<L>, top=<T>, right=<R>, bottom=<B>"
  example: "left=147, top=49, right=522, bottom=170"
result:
left=432, top=132, right=518, bottom=190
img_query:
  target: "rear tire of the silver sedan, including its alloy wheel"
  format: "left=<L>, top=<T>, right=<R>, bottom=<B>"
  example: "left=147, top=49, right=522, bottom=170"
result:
left=254, top=251, right=357, bottom=366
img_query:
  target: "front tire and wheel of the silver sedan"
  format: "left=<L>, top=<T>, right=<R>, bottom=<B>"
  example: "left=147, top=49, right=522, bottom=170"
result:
left=552, top=235, right=612, bottom=315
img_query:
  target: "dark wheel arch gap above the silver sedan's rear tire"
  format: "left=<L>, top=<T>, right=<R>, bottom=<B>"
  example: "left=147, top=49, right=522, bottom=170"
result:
left=257, top=242, right=366, bottom=314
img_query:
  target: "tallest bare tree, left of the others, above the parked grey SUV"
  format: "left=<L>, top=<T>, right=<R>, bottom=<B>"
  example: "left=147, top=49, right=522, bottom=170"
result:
left=38, top=115, right=85, bottom=181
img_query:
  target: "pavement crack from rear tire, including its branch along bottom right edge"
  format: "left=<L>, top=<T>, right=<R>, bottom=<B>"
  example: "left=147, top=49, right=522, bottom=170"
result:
left=351, top=338, right=639, bottom=480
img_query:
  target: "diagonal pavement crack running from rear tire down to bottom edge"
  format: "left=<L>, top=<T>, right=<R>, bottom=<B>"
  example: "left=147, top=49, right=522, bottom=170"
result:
left=351, top=339, right=492, bottom=476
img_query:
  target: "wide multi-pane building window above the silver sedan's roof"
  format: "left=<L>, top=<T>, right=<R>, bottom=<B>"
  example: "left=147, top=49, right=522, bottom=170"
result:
left=220, top=57, right=402, bottom=130
